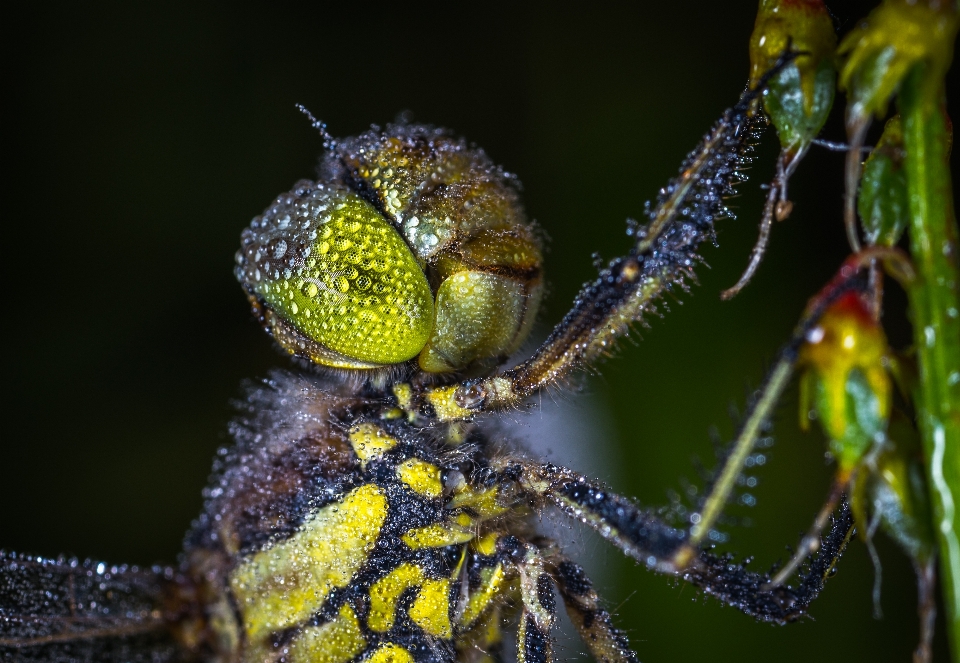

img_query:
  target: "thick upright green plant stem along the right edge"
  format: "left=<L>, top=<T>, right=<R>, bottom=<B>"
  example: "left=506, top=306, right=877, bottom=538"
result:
left=900, top=64, right=960, bottom=661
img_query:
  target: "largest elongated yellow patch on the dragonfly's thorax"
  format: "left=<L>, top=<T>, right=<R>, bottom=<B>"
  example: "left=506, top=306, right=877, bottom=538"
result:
left=230, top=484, right=387, bottom=642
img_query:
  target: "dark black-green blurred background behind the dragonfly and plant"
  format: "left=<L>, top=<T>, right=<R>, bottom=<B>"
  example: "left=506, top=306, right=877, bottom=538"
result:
left=0, top=0, right=960, bottom=662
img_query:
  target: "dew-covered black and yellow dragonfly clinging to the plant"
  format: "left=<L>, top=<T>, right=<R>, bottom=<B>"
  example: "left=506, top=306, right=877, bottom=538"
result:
left=0, top=48, right=853, bottom=663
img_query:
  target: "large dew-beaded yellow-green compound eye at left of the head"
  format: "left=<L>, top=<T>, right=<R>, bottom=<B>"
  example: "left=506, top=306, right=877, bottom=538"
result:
left=237, top=182, right=434, bottom=367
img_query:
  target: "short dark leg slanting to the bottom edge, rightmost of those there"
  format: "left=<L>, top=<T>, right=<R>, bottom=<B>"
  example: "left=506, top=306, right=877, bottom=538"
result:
left=549, top=555, right=638, bottom=663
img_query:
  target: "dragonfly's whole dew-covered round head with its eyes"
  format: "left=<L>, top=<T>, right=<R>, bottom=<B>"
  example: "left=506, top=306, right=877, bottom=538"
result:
left=237, top=125, right=542, bottom=373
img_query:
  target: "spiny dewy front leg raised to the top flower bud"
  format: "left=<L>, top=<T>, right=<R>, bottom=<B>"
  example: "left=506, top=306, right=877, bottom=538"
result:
left=419, top=53, right=796, bottom=420
